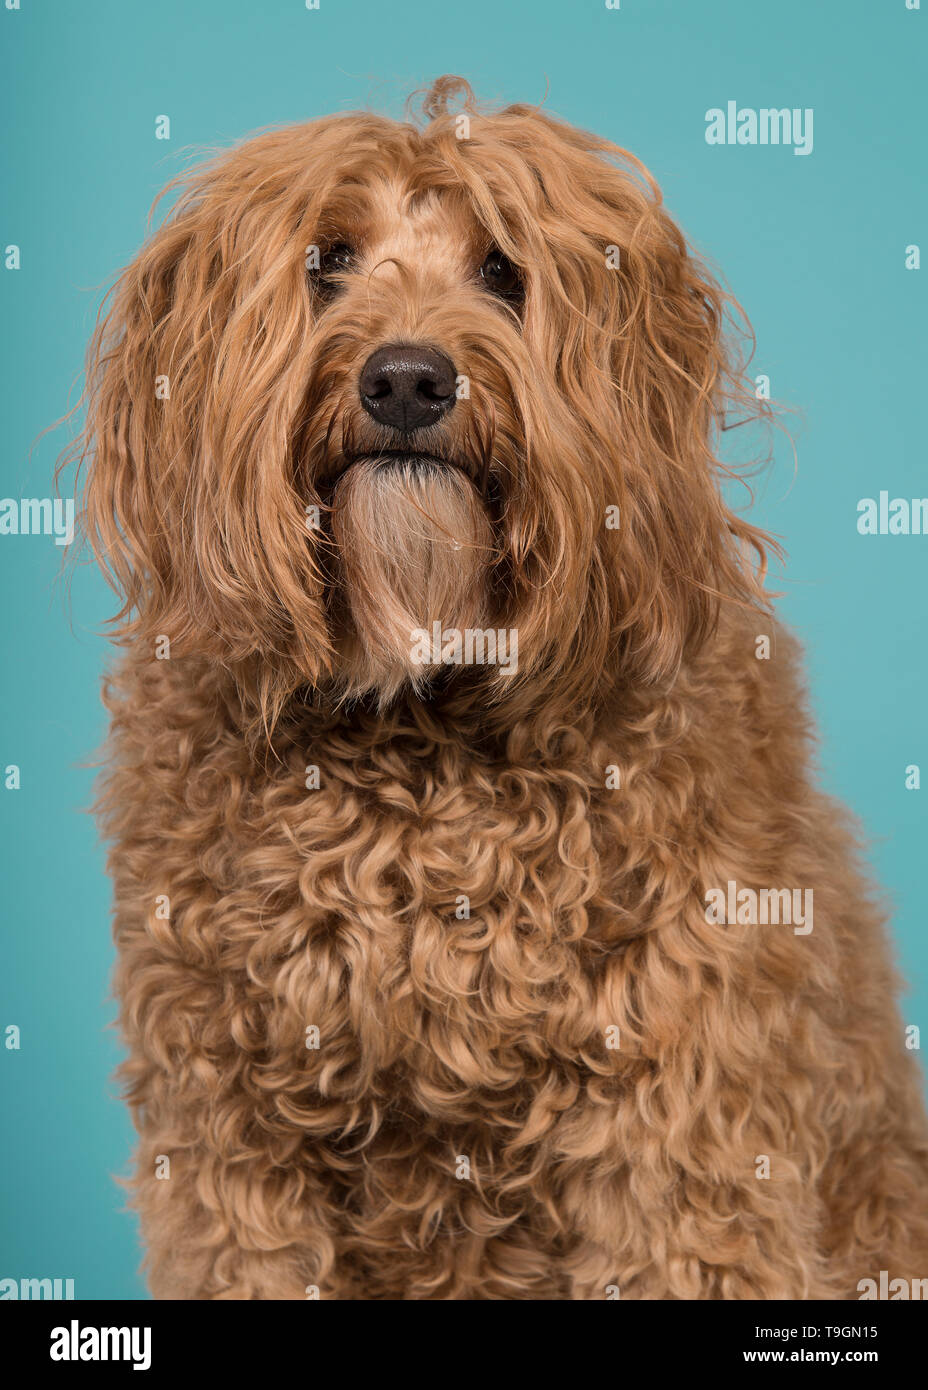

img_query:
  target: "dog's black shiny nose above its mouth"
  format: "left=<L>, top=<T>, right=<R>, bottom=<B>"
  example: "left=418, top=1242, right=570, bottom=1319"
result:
left=358, top=343, right=457, bottom=434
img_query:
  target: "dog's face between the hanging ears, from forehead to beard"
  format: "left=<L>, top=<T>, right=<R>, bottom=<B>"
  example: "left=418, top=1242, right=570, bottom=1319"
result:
left=296, top=169, right=525, bottom=701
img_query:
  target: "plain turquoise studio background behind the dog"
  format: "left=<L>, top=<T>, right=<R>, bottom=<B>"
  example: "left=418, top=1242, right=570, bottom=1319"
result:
left=0, top=0, right=928, bottom=1298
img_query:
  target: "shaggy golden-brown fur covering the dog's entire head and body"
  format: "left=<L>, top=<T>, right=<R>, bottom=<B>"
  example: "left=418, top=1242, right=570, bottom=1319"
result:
left=70, top=79, right=928, bottom=1300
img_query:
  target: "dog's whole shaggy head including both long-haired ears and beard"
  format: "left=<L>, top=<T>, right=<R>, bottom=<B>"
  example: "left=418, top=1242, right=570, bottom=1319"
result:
left=77, top=78, right=763, bottom=728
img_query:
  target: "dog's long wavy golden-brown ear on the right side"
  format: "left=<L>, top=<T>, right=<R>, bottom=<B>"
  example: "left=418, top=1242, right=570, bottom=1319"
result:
left=491, top=107, right=777, bottom=681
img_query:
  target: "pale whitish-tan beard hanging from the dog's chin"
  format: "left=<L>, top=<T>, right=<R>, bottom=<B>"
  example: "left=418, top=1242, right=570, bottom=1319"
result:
left=332, top=459, right=493, bottom=705
